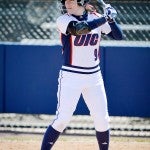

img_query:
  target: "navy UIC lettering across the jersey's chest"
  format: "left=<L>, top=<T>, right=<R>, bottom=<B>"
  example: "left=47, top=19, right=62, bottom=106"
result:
left=74, top=33, right=99, bottom=46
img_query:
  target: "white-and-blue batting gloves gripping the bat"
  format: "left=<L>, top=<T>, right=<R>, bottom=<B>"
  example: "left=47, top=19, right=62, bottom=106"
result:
left=104, top=4, right=117, bottom=21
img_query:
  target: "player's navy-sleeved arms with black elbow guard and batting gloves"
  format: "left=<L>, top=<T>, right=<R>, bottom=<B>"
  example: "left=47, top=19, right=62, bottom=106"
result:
left=67, top=7, right=123, bottom=40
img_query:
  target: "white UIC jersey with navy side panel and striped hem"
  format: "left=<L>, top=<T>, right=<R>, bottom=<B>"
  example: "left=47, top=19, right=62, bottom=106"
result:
left=57, top=13, right=111, bottom=74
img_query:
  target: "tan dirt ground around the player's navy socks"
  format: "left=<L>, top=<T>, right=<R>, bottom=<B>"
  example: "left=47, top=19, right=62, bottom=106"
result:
left=0, top=133, right=150, bottom=150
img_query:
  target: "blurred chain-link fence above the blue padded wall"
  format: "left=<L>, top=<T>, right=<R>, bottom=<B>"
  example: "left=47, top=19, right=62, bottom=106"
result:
left=0, top=0, right=150, bottom=45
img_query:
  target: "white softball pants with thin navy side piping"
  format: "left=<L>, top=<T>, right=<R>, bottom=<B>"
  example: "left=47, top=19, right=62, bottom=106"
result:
left=52, top=70, right=109, bottom=132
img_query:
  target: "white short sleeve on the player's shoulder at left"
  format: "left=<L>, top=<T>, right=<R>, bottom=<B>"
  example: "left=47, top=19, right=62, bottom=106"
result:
left=56, top=15, right=72, bottom=34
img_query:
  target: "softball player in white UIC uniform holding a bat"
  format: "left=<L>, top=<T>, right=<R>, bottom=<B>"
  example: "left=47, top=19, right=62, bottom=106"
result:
left=41, top=0, right=122, bottom=150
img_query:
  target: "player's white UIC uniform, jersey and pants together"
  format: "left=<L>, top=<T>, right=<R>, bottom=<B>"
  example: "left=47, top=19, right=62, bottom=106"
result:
left=52, top=13, right=111, bottom=132
